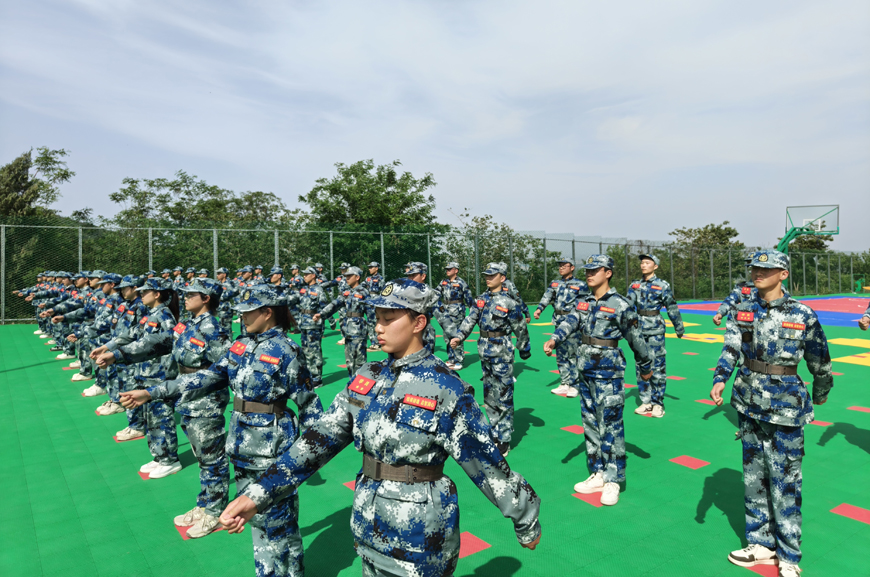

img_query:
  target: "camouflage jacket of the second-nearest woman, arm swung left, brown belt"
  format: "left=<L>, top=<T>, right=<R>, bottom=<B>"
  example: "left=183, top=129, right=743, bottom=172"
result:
left=148, top=328, right=323, bottom=470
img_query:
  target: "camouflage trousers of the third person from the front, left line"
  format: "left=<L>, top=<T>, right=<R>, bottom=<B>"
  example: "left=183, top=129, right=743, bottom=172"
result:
left=181, top=415, right=230, bottom=517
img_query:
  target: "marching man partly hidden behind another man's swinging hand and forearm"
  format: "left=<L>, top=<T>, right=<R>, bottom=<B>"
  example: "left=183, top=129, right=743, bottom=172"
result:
left=534, top=258, right=589, bottom=398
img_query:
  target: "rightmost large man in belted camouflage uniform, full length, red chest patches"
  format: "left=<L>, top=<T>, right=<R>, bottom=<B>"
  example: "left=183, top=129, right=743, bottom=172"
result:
left=710, top=249, right=834, bottom=577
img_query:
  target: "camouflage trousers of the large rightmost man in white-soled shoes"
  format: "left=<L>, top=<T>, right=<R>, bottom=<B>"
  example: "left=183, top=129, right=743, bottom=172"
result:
left=737, top=413, right=804, bottom=564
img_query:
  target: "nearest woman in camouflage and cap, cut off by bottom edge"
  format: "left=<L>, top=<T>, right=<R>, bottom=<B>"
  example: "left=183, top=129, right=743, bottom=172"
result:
left=221, top=279, right=541, bottom=577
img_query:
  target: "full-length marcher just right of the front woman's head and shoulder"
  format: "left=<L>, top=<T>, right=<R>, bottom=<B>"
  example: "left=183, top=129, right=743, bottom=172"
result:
left=450, top=262, right=532, bottom=457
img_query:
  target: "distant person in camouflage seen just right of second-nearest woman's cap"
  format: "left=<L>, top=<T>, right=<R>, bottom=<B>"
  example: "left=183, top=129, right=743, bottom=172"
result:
left=285, top=267, right=329, bottom=388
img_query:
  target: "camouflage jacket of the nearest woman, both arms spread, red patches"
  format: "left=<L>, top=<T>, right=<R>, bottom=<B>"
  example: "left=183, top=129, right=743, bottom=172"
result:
left=243, top=349, right=541, bottom=564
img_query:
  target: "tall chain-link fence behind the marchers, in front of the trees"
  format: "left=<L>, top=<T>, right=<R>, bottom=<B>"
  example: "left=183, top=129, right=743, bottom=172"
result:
left=0, top=224, right=870, bottom=322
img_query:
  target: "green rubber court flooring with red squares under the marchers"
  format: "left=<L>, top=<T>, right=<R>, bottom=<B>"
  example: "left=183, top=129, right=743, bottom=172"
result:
left=0, top=300, right=870, bottom=577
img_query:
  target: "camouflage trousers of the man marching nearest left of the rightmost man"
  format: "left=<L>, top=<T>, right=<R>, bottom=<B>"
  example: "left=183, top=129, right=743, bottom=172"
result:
left=580, top=374, right=625, bottom=483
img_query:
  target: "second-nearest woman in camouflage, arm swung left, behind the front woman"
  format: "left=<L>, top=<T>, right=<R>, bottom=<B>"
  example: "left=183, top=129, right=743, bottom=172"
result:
left=122, top=284, right=323, bottom=577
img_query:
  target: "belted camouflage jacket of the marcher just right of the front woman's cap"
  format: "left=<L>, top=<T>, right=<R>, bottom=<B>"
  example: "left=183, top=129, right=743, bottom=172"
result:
left=456, top=291, right=531, bottom=358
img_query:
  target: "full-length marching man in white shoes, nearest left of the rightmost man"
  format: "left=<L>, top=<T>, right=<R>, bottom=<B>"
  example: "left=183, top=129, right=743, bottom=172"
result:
left=544, top=254, right=652, bottom=505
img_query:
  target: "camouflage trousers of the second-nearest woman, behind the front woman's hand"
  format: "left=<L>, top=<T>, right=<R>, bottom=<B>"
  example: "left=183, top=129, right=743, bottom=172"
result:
left=234, top=466, right=305, bottom=577
